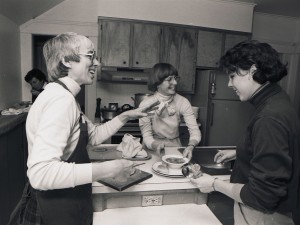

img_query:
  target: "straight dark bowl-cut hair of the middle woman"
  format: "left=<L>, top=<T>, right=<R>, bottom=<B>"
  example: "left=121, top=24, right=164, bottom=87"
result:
left=148, top=63, right=178, bottom=92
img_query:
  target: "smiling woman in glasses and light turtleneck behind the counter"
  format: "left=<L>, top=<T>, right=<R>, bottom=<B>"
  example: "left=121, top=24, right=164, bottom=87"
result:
left=139, top=63, right=201, bottom=159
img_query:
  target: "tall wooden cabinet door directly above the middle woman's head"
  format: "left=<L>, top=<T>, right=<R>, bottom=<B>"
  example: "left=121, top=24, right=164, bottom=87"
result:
left=161, top=27, right=197, bottom=93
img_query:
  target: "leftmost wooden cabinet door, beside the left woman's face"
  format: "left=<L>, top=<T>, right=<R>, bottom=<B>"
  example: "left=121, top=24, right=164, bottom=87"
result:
left=100, top=21, right=130, bottom=67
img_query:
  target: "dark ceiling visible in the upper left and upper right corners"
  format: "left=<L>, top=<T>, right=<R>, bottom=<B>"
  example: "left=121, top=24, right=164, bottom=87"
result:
left=0, top=0, right=300, bottom=25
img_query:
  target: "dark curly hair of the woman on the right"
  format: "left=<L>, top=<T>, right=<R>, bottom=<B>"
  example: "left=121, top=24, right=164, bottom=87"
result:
left=220, top=40, right=287, bottom=84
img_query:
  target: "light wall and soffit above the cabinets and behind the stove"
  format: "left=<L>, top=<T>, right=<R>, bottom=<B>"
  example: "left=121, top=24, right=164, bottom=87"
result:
left=21, top=0, right=254, bottom=118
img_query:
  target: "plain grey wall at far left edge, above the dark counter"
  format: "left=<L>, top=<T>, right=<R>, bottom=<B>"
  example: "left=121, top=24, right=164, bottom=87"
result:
left=0, top=14, right=22, bottom=110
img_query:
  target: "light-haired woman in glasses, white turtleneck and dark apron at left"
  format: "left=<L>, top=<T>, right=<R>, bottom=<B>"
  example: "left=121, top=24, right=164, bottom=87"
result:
left=9, top=33, right=157, bottom=225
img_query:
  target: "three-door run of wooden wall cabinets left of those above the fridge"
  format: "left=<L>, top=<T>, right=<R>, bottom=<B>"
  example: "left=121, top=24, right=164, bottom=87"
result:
left=99, top=17, right=197, bottom=93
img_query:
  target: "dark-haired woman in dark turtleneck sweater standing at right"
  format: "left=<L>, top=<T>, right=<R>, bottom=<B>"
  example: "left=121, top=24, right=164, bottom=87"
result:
left=191, top=40, right=300, bottom=225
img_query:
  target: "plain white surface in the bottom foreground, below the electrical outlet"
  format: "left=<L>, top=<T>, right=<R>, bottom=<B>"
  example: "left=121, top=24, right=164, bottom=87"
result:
left=93, top=204, right=222, bottom=225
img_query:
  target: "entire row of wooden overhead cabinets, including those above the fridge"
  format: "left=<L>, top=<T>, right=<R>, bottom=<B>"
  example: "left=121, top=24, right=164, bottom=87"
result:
left=98, top=17, right=249, bottom=93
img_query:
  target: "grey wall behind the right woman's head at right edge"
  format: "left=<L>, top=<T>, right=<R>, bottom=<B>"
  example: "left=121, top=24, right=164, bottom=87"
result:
left=252, top=13, right=300, bottom=113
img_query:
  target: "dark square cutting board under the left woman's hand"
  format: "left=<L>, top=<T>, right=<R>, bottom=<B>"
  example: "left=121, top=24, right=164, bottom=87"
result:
left=98, top=169, right=153, bottom=191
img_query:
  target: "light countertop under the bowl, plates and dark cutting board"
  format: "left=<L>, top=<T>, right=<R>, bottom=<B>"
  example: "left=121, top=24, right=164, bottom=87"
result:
left=93, top=147, right=230, bottom=194
